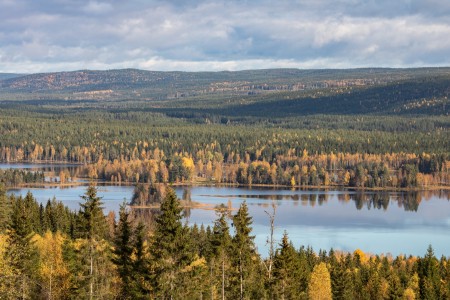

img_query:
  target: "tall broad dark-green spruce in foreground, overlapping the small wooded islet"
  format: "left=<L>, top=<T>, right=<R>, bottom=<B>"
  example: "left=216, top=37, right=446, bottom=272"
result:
left=150, top=188, right=192, bottom=299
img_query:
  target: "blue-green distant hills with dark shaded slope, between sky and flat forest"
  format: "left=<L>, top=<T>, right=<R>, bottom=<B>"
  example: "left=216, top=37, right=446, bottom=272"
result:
left=0, top=68, right=450, bottom=118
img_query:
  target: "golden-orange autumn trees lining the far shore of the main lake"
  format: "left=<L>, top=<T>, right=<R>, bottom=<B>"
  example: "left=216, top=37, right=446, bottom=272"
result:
left=85, top=151, right=450, bottom=188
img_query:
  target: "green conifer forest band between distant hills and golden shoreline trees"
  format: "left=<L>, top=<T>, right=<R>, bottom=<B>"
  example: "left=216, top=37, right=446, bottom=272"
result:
left=0, top=104, right=450, bottom=163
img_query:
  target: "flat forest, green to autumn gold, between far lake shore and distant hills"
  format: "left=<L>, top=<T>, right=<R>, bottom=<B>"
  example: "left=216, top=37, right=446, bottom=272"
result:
left=0, top=102, right=450, bottom=188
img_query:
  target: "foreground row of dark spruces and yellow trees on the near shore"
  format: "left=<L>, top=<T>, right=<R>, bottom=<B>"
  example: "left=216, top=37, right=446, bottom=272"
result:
left=0, top=186, right=450, bottom=299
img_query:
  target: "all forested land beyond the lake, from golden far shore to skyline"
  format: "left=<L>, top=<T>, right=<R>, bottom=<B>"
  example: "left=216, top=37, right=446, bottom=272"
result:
left=0, top=68, right=450, bottom=188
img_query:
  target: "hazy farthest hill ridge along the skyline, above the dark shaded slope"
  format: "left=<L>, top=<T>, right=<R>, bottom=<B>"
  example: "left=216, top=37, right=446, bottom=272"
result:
left=0, top=68, right=450, bottom=98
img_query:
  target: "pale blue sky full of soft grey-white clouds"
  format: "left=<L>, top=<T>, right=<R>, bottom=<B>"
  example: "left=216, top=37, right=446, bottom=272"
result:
left=0, top=0, right=450, bottom=73
